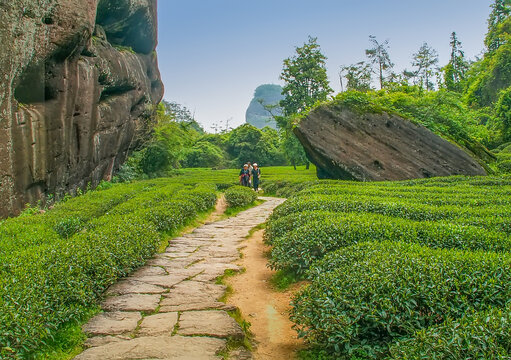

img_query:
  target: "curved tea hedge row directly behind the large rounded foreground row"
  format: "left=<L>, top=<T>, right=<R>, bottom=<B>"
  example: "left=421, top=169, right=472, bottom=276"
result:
left=270, top=213, right=511, bottom=275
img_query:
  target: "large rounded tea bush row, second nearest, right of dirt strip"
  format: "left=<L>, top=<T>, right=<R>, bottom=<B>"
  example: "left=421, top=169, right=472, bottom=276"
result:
left=292, top=242, right=511, bottom=358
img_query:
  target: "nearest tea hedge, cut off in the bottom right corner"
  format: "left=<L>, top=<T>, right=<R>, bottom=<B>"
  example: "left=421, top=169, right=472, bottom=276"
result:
left=389, top=306, right=511, bottom=360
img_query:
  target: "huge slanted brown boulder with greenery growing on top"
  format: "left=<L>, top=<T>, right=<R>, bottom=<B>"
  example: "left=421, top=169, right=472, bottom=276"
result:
left=295, top=104, right=486, bottom=181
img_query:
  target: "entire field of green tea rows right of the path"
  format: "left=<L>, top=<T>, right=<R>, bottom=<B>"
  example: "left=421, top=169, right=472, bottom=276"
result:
left=265, top=176, right=511, bottom=359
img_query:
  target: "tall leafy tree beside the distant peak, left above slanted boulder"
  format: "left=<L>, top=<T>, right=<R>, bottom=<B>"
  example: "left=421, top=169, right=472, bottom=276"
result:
left=280, top=36, right=333, bottom=116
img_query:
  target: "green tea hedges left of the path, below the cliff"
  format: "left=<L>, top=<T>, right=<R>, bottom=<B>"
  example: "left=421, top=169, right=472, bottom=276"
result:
left=0, top=178, right=217, bottom=358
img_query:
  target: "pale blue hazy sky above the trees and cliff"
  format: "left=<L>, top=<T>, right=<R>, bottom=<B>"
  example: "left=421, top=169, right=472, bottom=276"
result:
left=158, top=0, right=493, bottom=130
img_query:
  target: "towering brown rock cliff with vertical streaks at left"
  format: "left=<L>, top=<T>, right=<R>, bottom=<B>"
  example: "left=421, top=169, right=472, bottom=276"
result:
left=0, top=0, right=163, bottom=216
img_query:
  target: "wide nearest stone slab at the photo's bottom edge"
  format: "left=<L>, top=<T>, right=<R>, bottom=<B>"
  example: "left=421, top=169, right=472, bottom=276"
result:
left=75, top=336, right=226, bottom=360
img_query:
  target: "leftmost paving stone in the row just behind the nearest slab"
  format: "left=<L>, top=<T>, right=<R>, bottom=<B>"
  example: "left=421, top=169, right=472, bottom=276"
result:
left=83, top=311, right=142, bottom=335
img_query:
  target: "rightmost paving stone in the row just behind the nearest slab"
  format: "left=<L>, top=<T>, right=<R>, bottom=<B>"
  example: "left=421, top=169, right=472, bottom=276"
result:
left=178, top=310, right=244, bottom=339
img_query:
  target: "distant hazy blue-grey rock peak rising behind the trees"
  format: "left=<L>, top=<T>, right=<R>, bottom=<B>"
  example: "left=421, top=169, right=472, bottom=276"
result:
left=246, top=84, right=284, bottom=129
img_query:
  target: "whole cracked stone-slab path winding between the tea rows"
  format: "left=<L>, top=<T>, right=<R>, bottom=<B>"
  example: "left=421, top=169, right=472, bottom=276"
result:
left=75, top=198, right=284, bottom=360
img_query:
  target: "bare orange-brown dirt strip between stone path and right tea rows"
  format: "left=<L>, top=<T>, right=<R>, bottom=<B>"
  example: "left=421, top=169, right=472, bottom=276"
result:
left=227, top=230, right=303, bottom=360
